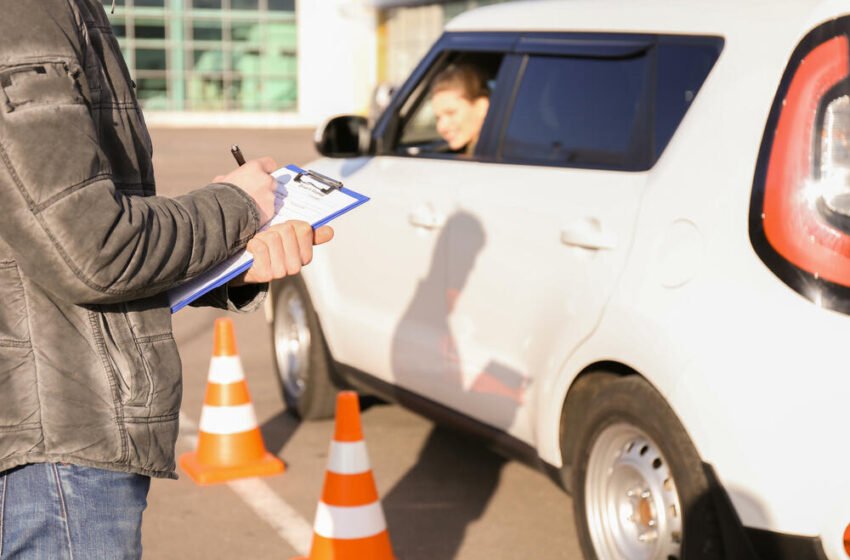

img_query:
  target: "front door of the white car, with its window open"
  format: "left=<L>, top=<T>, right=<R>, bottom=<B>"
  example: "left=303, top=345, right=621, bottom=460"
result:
left=305, top=36, right=513, bottom=396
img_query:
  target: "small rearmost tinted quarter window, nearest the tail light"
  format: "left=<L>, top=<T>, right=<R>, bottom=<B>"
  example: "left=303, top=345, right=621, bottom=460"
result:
left=655, top=39, right=722, bottom=159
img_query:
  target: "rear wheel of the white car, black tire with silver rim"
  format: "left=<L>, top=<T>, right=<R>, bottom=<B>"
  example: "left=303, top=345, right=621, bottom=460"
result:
left=569, top=375, right=723, bottom=560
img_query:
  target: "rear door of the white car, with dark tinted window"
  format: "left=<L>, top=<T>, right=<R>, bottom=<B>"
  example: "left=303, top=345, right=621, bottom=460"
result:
left=446, top=36, right=652, bottom=442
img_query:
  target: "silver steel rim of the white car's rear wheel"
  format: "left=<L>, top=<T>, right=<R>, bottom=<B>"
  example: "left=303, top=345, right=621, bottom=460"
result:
left=584, top=423, right=682, bottom=560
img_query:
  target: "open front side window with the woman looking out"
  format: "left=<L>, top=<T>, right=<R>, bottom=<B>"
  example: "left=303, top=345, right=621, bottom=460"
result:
left=394, top=52, right=504, bottom=157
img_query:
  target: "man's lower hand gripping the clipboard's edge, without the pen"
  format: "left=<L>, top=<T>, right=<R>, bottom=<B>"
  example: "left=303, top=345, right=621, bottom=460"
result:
left=235, top=221, right=334, bottom=286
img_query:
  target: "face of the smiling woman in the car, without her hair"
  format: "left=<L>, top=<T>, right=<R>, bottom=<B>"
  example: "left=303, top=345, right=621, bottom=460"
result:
left=431, top=89, right=490, bottom=150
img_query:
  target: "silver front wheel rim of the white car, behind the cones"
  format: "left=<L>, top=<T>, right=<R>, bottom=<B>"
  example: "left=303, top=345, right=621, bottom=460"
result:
left=274, top=286, right=310, bottom=400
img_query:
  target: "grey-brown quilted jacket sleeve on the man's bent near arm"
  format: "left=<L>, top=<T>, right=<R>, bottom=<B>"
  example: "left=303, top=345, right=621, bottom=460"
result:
left=0, top=65, right=259, bottom=304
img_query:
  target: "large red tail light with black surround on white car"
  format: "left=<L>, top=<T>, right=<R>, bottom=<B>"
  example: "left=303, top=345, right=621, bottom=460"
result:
left=750, top=18, right=850, bottom=313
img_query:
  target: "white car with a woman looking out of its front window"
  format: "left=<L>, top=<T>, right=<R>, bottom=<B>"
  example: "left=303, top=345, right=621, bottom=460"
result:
left=272, top=0, right=850, bottom=560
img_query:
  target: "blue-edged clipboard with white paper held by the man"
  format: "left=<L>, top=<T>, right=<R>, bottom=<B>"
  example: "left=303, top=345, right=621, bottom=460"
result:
left=168, top=165, right=369, bottom=313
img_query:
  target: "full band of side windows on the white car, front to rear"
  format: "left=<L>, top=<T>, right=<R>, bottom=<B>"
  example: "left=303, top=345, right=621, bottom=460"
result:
left=383, top=33, right=723, bottom=167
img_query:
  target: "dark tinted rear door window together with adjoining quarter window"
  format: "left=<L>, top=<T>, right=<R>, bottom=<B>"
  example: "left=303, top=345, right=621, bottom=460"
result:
left=498, top=37, right=723, bottom=171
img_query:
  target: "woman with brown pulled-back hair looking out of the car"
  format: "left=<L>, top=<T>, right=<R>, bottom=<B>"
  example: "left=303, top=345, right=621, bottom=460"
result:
left=431, top=64, right=490, bottom=156
